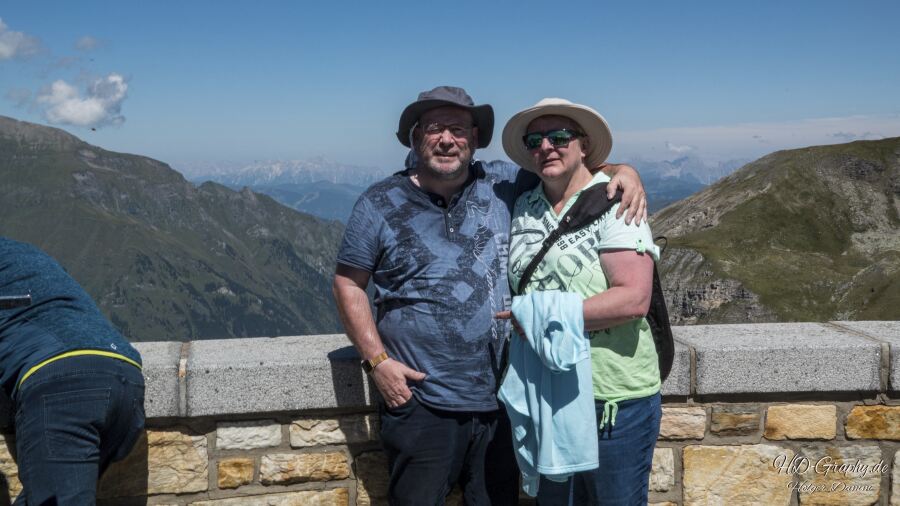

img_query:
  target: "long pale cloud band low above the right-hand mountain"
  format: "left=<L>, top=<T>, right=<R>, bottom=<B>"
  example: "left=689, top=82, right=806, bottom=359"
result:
left=613, top=114, right=900, bottom=160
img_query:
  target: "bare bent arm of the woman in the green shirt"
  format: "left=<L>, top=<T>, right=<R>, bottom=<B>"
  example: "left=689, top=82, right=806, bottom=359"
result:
left=584, top=249, right=653, bottom=330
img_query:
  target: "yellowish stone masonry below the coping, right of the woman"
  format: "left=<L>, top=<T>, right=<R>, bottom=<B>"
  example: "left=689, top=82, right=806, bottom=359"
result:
left=650, top=399, right=900, bottom=505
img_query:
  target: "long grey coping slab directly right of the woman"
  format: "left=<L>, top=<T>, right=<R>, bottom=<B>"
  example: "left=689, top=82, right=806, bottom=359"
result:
left=673, top=323, right=881, bottom=395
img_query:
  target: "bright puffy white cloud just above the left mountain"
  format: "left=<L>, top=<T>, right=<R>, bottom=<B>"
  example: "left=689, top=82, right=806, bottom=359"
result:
left=36, top=74, right=128, bottom=127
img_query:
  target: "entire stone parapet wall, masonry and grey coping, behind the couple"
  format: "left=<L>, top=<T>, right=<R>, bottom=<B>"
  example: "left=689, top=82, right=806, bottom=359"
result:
left=0, top=322, right=900, bottom=506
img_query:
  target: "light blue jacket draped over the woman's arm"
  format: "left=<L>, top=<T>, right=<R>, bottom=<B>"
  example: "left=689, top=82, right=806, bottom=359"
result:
left=499, top=290, right=598, bottom=497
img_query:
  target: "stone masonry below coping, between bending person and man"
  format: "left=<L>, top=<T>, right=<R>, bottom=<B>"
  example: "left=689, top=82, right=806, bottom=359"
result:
left=99, top=413, right=387, bottom=505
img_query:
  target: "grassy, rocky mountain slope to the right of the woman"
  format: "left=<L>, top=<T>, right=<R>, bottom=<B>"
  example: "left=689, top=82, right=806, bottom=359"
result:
left=651, top=139, right=900, bottom=323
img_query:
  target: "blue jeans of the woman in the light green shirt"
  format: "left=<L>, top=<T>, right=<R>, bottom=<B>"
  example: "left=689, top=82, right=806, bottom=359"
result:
left=537, top=393, right=662, bottom=506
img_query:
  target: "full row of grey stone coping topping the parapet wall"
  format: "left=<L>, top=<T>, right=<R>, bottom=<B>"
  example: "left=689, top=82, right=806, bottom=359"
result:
left=0, top=321, right=900, bottom=422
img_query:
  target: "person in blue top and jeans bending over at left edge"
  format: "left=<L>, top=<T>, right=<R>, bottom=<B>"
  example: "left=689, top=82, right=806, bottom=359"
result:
left=0, top=237, right=144, bottom=505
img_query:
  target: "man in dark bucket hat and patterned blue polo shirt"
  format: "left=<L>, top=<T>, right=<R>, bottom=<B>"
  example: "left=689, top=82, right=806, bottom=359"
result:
left=333, top=86, right=644, bottom=505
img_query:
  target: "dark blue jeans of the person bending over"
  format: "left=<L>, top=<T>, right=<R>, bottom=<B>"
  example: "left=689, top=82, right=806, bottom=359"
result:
left=14, top=355, right=144, bottom=505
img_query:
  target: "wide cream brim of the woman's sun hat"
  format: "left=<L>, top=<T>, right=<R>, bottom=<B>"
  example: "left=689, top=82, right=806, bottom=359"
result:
left=503, top=103, right=612, bottom=172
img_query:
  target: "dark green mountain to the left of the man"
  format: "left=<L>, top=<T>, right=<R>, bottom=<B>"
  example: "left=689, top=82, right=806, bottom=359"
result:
left=0, top=117, right=342, bottom=340
